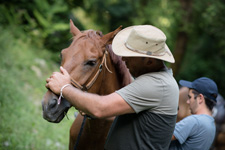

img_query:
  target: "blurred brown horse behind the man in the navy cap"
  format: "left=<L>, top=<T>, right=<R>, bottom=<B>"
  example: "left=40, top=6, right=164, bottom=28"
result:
left=177, top=87, right=225, bottom=150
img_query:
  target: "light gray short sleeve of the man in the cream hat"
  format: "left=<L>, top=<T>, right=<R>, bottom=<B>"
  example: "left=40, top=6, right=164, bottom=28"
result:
left=116, top=75, right=163, bottom=113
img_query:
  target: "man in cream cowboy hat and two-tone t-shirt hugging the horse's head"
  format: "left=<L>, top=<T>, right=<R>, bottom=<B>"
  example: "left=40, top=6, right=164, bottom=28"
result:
left=46, top=25, right=179, bottom=150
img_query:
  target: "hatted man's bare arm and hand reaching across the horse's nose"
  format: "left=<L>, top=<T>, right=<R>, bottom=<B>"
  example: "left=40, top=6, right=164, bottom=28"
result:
left=46, top=67, right=134, bottom=118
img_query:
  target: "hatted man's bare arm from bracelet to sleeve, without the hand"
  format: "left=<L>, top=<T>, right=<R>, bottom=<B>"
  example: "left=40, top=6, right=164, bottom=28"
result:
left=63, top=86, right=134, bottom=118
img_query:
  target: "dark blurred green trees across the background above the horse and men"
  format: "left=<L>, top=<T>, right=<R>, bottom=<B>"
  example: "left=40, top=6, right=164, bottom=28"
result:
left=0, top=0, right=225, bottom=93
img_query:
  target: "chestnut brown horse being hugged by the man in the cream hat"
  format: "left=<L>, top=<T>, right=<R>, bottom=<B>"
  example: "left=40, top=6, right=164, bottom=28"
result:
left=42, top=20, right=132, bottom=150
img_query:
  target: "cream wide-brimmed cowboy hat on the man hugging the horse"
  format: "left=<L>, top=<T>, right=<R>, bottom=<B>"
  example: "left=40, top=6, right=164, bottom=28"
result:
left=112, top=25, right=175, bottom=63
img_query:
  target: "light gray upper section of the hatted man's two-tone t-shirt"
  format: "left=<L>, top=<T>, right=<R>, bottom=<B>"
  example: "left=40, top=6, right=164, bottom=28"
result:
left=116, top=69, right=179, bottom=115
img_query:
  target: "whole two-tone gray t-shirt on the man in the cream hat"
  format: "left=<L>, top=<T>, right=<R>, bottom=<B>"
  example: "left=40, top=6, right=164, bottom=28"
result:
left=105, top=69, right=179, bottom=150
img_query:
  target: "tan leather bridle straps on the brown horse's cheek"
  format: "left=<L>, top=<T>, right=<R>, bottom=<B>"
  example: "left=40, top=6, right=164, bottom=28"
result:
left=71, top=46, right=112, bottom=91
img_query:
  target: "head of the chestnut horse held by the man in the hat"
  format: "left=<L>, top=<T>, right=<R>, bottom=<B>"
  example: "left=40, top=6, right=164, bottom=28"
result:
left=42, top=20, right=121, bottom=123
